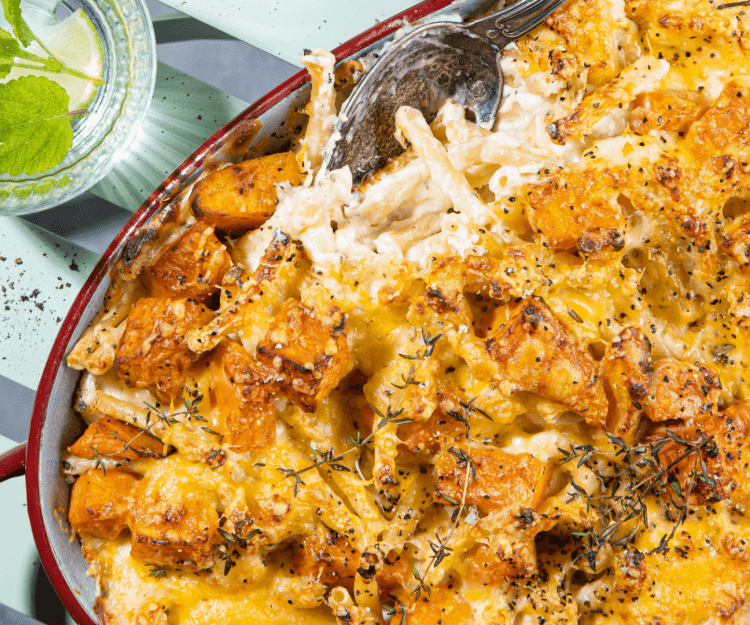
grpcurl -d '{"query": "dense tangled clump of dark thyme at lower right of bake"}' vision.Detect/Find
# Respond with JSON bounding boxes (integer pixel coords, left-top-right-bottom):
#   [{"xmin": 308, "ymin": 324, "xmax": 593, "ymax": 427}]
[{"xmin": 559, "ymin": 430, "xmax": 716, "ymax": 569}]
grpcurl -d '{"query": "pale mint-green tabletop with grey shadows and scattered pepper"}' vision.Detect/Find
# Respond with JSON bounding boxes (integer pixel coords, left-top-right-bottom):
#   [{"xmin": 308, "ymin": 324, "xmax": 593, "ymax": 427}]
[{"xmin": 0, "ymin": 0, "xmax": 416, "ymax": 625}]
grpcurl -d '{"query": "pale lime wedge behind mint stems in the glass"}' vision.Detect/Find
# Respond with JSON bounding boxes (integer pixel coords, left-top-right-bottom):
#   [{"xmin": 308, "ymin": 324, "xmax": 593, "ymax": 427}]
[{"xmin": 0, "ymin": 9, "xmax": 102, "ymax": 111}]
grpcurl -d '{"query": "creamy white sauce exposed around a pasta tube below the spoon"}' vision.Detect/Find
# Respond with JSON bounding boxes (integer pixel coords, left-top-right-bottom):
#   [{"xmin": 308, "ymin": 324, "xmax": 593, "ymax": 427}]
[{"xmin": 234, "ymin": 50, "xmax": 592, "ymax": 273}]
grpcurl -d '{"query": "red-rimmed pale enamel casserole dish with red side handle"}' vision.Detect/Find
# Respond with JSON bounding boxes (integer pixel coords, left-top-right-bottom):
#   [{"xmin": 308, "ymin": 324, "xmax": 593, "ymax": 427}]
[{"xmin": 0, "ymin": 0, "xmax": 494, "ymax": 625}]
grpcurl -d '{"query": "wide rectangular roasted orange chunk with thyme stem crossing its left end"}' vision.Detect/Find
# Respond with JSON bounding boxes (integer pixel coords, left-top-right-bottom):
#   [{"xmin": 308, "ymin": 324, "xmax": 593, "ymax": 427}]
[{"xmin": 434, "ymin": 444, "xmax": 552, "ymax": 511}]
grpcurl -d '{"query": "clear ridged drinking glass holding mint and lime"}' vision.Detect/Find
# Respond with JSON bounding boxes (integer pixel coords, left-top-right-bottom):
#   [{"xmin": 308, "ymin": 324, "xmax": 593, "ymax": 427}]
[{"xmin": 0, "ymin": 0, "xmax": 156, "ymax": 215}]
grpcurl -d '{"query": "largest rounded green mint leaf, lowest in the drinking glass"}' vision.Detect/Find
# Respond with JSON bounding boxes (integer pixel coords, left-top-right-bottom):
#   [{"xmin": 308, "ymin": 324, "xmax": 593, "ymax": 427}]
[{"xmin": 0, "ymin": 75, "xmax": 73, "ymax": 176}]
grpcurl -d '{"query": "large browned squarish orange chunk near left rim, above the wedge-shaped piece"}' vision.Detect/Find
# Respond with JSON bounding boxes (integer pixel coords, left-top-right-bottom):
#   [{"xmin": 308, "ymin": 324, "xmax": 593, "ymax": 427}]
[{"xmin": 115, "ymin": 297, "xmax": 213, "ymax": 400}]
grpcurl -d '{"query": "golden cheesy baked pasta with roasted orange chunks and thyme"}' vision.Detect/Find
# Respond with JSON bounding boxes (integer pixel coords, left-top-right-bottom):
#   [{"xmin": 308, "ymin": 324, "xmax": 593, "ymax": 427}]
[{"xmin": 62, "ymin": 0, "xmax": 750, "ymax": 625}]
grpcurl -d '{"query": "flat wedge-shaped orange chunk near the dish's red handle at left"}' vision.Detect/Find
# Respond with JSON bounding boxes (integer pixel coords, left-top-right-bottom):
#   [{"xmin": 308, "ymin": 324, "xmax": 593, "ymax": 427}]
[{"xmin": 68, "ymin": 417, "xmax": 167, "ymax": 460}]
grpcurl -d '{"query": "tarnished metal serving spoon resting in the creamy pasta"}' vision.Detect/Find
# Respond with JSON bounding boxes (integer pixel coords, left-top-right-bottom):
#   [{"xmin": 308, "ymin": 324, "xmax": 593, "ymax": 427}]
[{"xmin": 323, "ymin": 0, "xmax": 563, "ymax": 183}]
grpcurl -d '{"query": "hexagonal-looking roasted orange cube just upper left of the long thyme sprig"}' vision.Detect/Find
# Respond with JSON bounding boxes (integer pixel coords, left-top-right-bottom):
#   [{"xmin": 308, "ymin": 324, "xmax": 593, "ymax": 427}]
[{"xmin": 258, "ymin": 299, "xmax": 349, "ymax": 412}]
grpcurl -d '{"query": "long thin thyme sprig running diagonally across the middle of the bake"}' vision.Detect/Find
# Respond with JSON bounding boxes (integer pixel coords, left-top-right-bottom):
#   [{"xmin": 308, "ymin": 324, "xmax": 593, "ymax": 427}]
[{"xmin": 276, "ymin": 330, "xmax": 443, "ymax": 497}]
